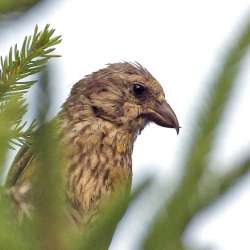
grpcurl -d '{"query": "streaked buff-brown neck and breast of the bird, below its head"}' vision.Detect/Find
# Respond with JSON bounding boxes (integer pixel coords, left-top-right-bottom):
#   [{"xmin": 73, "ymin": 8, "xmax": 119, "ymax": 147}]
[{"xmin": 61, "ymin": 114, "xmax": 136, "ymax": 222}]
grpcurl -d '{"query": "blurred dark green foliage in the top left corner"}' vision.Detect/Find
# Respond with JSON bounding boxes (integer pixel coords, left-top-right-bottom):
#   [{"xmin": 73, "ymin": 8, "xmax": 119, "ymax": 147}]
[{"xmin": 0, "ymin": 0, "xmax": 42, "ymax": 16}]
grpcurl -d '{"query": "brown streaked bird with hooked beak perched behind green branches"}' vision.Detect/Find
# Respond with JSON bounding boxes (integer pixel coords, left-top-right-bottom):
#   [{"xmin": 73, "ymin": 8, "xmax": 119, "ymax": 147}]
[{"xmin": 7, "ymin": 62, "xmax": 180, "ymax": 224}]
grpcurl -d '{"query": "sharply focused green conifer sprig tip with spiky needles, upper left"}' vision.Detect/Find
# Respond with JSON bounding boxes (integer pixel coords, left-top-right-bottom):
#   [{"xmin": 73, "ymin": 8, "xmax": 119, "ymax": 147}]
[{"xmin": 0, "ymin": 25, "xmax": 61, "ymax": 98}]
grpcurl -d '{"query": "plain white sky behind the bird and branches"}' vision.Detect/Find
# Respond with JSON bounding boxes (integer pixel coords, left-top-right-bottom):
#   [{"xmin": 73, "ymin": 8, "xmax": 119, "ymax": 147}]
[{"xmin": 0, "ymin": 0, "xmax": 250, "ymax": 250}]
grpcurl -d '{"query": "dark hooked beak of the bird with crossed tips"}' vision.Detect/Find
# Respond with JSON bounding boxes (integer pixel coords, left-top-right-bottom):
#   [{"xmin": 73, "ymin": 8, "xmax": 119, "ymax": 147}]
[{"xmin": 144, "ymin": 101, "xmax": 180, "ymax": 134}]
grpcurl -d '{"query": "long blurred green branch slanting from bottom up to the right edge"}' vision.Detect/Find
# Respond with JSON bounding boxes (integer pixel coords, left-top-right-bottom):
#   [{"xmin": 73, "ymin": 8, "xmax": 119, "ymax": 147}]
[{"xmin": 143, "ymin": 16, "xmax": 250, "ymax": 250}]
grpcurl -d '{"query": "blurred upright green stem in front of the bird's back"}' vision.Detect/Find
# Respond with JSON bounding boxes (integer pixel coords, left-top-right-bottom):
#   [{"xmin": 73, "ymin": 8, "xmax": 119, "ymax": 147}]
[{"xmin": 31, "ymin": 67, "xmax": 69, "ymax": 250}]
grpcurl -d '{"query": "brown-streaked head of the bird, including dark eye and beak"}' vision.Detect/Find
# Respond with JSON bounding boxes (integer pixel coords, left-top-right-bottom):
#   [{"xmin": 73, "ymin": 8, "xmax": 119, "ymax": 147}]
[{"xmin": 67, "ymin": 62, "xmax": 180, "ymax": 134}]
